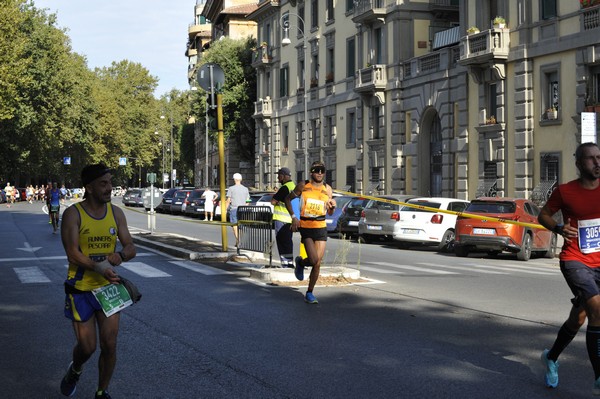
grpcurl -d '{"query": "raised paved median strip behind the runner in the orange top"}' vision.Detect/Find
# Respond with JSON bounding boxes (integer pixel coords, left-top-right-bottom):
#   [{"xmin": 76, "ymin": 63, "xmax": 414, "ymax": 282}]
[{"xmin": 132, "ymin": 233, "xmax": 360, "ymax": 285}]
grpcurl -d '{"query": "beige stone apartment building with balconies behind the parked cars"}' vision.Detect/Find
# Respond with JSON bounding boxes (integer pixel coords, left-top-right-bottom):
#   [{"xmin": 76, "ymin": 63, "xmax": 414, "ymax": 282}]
[{"xmin": 248, "ymin": 0, "xmax": 600, "ymax": 202}]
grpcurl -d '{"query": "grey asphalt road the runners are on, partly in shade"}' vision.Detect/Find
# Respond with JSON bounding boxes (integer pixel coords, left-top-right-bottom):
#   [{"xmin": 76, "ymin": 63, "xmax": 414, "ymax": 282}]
[{"xmin": 0, "ymin": 200, "xmax": 593, "ymax": 398}]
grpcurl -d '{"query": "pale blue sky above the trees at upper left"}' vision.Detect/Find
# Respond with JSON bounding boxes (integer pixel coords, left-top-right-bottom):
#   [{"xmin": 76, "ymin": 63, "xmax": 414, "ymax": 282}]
[{"xmin": 34, "ymin": 0, "xmax": 196, "ymax": 97}]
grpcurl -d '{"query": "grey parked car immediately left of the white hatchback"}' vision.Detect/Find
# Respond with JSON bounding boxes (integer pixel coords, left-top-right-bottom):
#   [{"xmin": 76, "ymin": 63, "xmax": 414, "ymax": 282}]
[{"xmin": 358, "ymin": 195, "xmax": 415, "ymax": 243}]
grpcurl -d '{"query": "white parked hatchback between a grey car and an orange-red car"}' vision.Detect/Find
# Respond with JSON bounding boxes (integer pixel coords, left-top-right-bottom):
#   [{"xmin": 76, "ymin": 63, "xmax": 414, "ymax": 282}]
[{"xmin": 394, "ymin": 197, "xmax": 469, "ymax": 252}]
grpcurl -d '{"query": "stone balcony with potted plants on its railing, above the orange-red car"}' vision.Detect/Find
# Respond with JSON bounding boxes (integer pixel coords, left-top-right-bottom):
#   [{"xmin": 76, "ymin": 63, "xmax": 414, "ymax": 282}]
[{"xmin": 458, "ymin": 28, "xmax": 510, "ymax": 81}]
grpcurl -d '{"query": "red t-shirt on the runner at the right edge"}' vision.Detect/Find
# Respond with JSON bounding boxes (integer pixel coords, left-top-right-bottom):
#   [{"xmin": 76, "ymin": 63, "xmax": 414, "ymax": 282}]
[{"xmin": 546, "ymin": 180, "xmax": 600, "ymax": 267}]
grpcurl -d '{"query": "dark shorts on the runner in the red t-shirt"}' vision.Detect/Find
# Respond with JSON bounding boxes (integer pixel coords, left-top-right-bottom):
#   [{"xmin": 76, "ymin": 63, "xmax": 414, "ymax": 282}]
[{"xmin": 560, "ymin": 260, "xmax": 600, "ymax": 306}]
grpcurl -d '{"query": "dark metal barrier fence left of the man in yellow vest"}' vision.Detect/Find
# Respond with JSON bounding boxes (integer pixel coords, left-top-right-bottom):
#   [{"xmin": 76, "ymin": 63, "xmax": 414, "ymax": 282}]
[{"xmin": 237, "ymin": 206, "xmax": 273, "ymax": 267}]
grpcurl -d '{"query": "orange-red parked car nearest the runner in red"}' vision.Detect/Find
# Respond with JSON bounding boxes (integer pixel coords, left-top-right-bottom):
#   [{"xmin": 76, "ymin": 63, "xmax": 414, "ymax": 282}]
[{"xmin": 454, "ymin": 197, "xmax": 557, "ymax": 261}]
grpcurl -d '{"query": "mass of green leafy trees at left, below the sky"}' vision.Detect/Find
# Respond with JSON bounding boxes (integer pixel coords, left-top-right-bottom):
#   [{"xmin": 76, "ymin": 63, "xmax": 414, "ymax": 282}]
[{"xmin": 0, "ymin": 0, "xmax": 189, "ymax": 186}]
